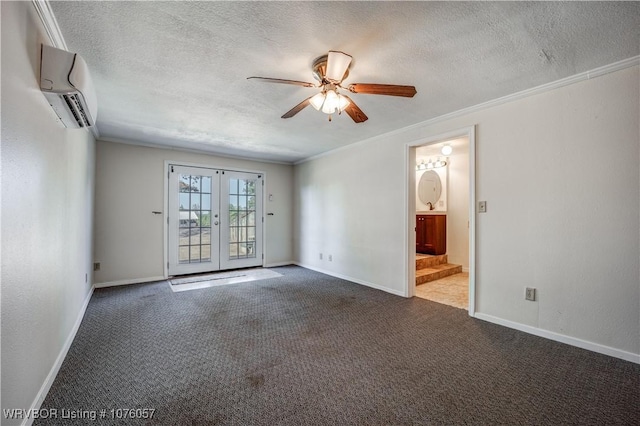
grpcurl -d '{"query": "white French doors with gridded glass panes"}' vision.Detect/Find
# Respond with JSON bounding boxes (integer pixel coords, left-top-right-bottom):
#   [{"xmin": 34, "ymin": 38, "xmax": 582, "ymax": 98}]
[{"xmin": 167, "ymin": 164, "xmax": 264, "ymax": 275}]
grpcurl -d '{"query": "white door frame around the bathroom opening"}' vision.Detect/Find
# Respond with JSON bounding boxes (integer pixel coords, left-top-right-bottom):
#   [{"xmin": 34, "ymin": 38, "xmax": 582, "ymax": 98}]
[{"xmin": 404, "ymin": 125, "xmax": 476, "ymax": 317}]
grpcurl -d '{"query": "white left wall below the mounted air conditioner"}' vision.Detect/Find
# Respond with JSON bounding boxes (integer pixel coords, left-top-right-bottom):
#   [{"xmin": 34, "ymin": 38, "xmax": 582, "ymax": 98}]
[{"xmin": 1, "ymin": 2, "xmax": 95, "ymax": 424}]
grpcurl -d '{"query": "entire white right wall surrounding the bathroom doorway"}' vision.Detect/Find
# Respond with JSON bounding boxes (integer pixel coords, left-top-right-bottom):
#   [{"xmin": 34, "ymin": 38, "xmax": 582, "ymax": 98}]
[{"xmin": 294, "ymin": 65, "xmax": 640, "ymax": 360}]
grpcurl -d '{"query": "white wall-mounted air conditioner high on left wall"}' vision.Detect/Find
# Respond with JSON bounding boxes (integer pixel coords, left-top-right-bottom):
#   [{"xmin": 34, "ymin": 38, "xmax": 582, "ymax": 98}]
[{"xmin": 40, "ymin": 45, "xmax": 98, "ymax": 129}]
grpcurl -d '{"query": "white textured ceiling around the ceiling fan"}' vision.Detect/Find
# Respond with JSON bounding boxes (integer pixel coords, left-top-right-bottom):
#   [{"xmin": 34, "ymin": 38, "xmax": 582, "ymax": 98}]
[{"xmin": 51, "ymin": 1, "xmax": 640, "ymax": 162}]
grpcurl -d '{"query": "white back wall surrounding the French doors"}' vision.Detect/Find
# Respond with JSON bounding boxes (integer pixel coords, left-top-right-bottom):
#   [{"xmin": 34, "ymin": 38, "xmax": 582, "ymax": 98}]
[{"xmin": 94, "ymin": 141, "xmax": 293, "ymax": 285}]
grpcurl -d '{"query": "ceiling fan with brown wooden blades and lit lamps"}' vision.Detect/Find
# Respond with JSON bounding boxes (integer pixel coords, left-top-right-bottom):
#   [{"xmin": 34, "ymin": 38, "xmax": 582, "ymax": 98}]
[{"xmin": 247, "ymin": 50, "xmax": 417, "ymax": 123}]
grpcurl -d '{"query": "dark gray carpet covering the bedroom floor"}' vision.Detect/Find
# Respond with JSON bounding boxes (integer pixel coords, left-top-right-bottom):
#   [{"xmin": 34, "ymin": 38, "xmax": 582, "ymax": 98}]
[{"xmin": 36, "ymin": 266, "xmax": 640, "ymax": 425}]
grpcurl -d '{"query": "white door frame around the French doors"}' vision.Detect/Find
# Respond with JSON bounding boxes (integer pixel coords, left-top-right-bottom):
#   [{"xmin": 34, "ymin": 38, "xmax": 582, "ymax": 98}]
[{"xmin": 162, "ymin": 160, "xmax": 267, "ymax": 280}]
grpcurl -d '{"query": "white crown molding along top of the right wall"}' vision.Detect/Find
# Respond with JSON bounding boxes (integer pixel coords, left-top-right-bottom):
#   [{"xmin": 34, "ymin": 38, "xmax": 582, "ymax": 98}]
[{"xmin": 294, "ymin": 56, "xmax": 640, "ymax": 165}]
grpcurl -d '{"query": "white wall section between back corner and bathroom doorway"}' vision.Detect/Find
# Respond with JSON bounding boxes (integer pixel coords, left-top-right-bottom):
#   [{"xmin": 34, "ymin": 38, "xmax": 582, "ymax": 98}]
[{"xmin": 294, "ymin": 138, "xmax": 408, "ymax": 294}]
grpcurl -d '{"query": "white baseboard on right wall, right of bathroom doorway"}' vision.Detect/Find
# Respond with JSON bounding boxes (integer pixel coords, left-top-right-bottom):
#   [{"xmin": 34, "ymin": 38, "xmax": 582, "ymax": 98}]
[{"xmin": 474, "ymin": 312, "xmax": 640, "ymax": 364}]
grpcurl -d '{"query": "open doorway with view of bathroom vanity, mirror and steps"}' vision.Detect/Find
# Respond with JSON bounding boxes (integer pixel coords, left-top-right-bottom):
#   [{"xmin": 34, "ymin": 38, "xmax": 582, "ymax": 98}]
[{"xmin": 407, "ymin": 127, "xmax": 475, "ymax": 316}]
